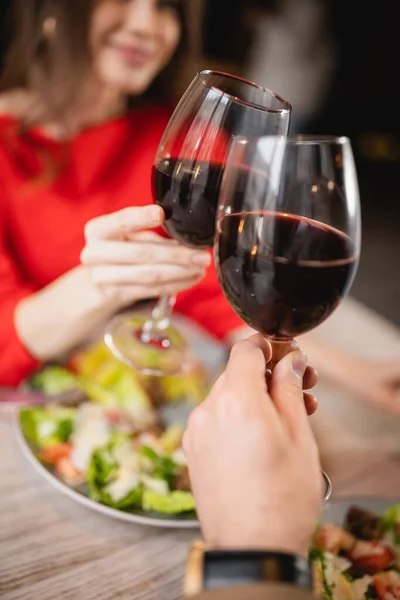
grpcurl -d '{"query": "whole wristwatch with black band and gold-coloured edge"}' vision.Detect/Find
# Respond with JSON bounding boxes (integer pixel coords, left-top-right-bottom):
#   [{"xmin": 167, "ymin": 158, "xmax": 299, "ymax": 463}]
[{"xmin": 184, "ymin": 542, "xmax": 313, "ymax": 598}]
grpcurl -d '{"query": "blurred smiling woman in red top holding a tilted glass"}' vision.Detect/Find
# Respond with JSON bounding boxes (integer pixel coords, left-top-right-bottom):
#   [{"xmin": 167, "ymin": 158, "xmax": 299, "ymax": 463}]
[{"xmin": 0, "ymin": 0, "xmax": 247, "ymax": 385}]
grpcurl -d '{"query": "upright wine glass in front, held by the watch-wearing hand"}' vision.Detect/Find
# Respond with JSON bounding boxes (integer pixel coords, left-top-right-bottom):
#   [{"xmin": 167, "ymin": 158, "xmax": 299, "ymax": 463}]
[{"xmin": 215, "ymin": 136, "xmax": 361, "ymax": 370}]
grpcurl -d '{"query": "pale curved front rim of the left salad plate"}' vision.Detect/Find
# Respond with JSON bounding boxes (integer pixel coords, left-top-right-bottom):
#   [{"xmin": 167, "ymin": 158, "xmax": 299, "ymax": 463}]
[{"xmin": 13, "ymin": 407, "xmax": 200, "ymax": 529}]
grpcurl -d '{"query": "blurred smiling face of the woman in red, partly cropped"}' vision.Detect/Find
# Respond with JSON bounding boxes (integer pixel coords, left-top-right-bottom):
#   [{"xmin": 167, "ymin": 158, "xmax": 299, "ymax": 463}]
[{"xmin": 90, "ymin": 0, "xmax": 181, "ymax": 96}]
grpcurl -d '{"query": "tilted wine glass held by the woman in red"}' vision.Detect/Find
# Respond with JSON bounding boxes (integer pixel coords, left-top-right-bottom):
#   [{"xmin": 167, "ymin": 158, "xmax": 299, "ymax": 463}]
[{"xmin": 105, "ymin": 71, "xmax": 291, "ymax": 375}]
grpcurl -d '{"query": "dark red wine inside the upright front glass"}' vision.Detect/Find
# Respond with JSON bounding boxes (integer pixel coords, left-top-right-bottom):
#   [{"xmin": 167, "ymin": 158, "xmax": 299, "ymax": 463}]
[{"xmin": 218, "ymin": 211, "xmax": 357, "ymax": 340}]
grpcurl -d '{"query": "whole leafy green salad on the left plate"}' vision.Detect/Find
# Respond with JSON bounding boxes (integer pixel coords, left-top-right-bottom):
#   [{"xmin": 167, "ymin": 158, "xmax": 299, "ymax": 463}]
[{"xmin": 20, "ymin": 343, "xmax": 208, "ymax": 516}]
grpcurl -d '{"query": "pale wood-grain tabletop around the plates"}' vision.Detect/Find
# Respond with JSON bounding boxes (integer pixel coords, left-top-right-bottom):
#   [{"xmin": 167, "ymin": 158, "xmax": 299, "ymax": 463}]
[{"xmin": 0, "ymin": 300, "xmax": 400, "ymax": 600}]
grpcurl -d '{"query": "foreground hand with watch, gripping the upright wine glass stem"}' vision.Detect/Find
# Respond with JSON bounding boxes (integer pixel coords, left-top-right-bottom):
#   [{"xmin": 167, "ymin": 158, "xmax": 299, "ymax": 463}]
[{"xmin": 183, "ymin": 335, "xmax": 322, "ymax": 553}]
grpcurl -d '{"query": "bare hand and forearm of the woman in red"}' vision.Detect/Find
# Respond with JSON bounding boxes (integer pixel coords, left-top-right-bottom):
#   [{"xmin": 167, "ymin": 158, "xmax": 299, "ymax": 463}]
[{"xmin": 15, "ymin": 206, "xmax": 211, "ymax": 361}]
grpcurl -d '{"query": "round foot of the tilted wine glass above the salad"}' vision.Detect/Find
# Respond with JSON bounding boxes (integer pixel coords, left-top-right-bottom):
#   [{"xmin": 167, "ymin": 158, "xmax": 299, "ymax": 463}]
[{"xmin": 104, "ymin": 312, "xmax": 191, "ymax": 377}]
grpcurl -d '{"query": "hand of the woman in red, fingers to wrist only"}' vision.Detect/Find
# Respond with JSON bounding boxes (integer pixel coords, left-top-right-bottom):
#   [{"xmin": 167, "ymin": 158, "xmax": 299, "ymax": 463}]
[{"xmin": 81, "ymin": 205, "xmax": 211, "ymax": 308}]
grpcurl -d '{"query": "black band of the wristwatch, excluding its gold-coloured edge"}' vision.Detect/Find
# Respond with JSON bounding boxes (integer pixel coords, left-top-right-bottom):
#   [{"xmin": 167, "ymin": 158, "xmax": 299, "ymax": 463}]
[{"xmin": 203, "ymin": 550, "xmax": 313, "ymax": 590}]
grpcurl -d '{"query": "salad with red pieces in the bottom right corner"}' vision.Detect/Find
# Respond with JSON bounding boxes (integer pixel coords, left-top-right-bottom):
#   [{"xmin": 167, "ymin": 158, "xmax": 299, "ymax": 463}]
[{"xmin": 310, "ymin": 505, "xmax": 400, "ymax": 600}]
